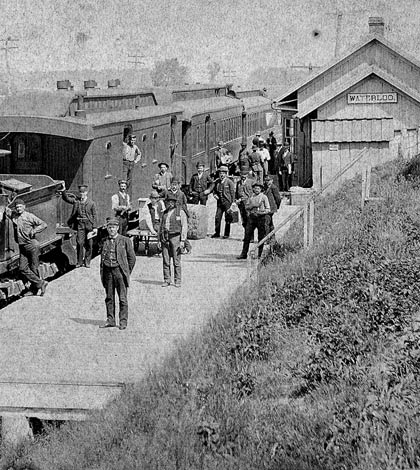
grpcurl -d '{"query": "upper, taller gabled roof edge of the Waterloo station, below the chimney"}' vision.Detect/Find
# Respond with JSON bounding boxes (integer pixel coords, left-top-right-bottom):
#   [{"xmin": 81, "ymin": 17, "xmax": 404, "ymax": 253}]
[{"xmin": 273, "ymin": 34, "xmax": 420, "ymax": 102}]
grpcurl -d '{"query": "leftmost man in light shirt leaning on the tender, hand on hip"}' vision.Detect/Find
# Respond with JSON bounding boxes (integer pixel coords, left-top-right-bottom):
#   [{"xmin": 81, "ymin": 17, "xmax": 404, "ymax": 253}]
[{"xmin": 6, "ymin": 198, "xmax": 48, "ymax": 296}]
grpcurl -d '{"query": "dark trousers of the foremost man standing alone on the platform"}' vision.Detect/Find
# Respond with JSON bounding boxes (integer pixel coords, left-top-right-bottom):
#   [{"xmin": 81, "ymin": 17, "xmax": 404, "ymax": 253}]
[{"xmin": 103, "ymin": 266, "xmax": 128, "ymax": 326}]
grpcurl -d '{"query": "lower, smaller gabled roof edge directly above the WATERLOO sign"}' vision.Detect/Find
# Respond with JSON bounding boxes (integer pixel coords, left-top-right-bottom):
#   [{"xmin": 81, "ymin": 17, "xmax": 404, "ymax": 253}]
[{"xmin": 296, "ymin": 64, "xmax": 420, "ymax": 119}]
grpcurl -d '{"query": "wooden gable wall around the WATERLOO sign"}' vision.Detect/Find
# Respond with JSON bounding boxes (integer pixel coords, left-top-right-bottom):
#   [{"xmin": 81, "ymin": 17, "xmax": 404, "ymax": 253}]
[{"xmin": 318, "ymin": 76, "xmax": 420, "ymax": 131}]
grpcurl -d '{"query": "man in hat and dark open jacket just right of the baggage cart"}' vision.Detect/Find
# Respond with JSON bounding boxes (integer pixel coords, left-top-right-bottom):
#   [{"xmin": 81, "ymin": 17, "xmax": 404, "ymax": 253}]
[{"xmin": 211, "ymin": 165, "xmax": 235, "ymax": 238}]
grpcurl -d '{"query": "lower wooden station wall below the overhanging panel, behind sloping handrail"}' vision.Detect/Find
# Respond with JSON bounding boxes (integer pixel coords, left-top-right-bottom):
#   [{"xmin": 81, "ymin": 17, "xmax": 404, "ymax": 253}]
[{"xmin": 312, "ymin": 142, "xmax": 392, "ymax": 192}]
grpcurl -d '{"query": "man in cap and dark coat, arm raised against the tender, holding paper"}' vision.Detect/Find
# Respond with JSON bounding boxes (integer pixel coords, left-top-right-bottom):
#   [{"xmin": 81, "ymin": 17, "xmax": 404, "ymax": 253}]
[{"xmin": 62, "ymin": 184, "xmax": 97, "ymax": 268}]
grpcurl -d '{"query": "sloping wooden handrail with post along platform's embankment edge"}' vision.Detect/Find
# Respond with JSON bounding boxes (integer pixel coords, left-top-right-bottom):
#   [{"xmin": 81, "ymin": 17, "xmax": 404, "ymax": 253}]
[{"xmin": 252, "ymin": 147, "xmax": 368, "ymax": 259}]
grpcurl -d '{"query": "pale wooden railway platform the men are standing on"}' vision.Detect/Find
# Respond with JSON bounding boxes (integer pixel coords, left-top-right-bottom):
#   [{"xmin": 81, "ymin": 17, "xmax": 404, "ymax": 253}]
[{"xmin": 0, "ymin": 196, "xmax": 296, "ymax": 441}]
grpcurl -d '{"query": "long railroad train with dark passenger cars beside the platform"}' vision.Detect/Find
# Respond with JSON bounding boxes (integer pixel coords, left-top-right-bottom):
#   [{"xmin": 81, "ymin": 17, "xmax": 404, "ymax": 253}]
[{"xmin": 0, "ymin": 80, "xmax": 278, "ymax": 298}]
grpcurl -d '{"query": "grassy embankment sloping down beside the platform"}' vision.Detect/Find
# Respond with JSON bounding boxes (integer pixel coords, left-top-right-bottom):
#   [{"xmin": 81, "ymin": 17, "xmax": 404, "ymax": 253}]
[{"xmin": 0, "ymin": 159, "xmax": 420, "ymax": 470}]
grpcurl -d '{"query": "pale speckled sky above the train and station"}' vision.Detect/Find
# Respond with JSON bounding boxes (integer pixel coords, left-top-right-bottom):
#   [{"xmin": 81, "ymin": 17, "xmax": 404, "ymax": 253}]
[{"xmin": 0, "ymin": 0, "xmax": 420, "ymax": 80}]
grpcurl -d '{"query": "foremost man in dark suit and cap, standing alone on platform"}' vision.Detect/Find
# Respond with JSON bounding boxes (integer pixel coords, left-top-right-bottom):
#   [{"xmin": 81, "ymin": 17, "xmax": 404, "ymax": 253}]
[{"xmin": 99, "ymin": 217, "xmax": 136, "ymax": 330}]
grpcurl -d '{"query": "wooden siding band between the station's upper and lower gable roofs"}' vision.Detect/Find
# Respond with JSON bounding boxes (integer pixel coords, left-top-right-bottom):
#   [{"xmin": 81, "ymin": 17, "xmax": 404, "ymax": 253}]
[{"xmin": 298, "ymin": 41, "xmax": 420, "ymax": 108}]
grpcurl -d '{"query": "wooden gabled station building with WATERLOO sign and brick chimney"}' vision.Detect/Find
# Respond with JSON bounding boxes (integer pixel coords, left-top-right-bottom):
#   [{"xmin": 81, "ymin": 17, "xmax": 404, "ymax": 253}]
[{"xmin": 274, "ymin": 17, "xmax": 420, "ymax": 189}]
